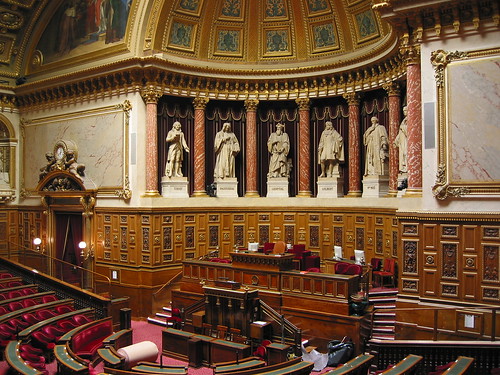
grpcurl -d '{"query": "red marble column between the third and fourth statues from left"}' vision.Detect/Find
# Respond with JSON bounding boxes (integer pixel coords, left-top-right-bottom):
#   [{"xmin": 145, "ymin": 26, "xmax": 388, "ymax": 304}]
[{"xmin": 296, "ymin": 98, "xmax": 311, "ymax": 197}]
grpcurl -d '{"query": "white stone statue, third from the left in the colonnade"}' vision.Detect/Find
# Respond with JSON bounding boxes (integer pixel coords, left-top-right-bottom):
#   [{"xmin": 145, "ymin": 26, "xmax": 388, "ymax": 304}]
[{"xmin": 267, "ymin": 123, "xmax": 291, "ymax": 178}]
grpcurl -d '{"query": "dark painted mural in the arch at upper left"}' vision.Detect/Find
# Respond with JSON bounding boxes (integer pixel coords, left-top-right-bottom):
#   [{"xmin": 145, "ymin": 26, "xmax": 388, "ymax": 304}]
[{"xmin": 37, "ymin": 0, "xmax": 132, "ymax": 64}]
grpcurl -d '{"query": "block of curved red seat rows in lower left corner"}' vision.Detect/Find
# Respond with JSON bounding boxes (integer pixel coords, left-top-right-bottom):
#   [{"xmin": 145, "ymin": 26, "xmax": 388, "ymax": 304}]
[{"xmin": 0, "ymin": 271, "xmax": 94, "ymax": 374}]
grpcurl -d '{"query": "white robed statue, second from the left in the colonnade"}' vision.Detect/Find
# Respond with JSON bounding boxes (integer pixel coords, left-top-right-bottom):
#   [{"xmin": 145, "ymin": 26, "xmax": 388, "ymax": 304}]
[{"xmin": 214, "ymin": 122, "xmax": 240, "ymax": 179}]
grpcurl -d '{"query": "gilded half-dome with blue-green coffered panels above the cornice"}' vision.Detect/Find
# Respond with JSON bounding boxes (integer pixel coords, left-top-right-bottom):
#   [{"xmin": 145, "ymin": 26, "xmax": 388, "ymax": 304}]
[{"xmin": 150, "ymin": 0, "xmax": 395, "ymax": 73}]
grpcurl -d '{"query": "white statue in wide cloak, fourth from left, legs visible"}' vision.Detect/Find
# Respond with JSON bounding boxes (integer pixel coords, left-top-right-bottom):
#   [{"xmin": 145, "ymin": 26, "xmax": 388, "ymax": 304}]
[{"xmin": 318, "ymin": 121, "xmax": 344, "ymax": 177}]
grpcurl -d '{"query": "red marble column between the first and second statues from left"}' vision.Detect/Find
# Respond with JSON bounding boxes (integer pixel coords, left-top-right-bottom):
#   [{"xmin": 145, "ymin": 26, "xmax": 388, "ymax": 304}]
[{"xmin": 193, "ymin": 97, "xmax": 209, "ymax": 197}]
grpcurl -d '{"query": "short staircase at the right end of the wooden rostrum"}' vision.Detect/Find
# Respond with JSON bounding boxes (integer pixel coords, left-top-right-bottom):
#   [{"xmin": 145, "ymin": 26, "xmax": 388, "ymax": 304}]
[{"xmin": 368, "ymin": 288, "xmax": 398, "ymax": 340}]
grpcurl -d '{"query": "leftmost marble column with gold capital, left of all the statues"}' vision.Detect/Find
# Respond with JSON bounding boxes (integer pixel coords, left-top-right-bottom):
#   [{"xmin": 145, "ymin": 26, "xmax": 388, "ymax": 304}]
[{"xmin": 141, "ymin": 87, "xmax": 162, "ymax": 197}]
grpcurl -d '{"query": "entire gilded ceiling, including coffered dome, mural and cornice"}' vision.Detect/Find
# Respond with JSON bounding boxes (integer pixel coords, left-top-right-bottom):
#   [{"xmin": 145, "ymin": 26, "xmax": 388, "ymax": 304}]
[{"xmin": 0, "ymin": 0, "xmax": 499, "ymax": 106}]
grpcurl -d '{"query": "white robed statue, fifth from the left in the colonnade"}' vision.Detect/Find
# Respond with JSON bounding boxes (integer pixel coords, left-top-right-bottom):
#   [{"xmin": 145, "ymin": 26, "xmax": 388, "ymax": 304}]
[{"xmin": 363, "ymin": 116, "xmax": 389, "ymax": 176}]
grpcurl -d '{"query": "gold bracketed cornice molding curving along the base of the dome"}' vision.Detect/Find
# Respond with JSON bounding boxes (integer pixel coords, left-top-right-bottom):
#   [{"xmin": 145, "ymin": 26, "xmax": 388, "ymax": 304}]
[{"xmin": 15, "ymin": 55, "xmax": 406, "ymax": 109}]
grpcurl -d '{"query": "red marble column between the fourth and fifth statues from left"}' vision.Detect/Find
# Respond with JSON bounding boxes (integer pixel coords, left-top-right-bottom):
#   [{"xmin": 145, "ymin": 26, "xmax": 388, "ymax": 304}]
[{"xmin": 344, "ymin": 92, "xmax": 362, "ymax": 197}]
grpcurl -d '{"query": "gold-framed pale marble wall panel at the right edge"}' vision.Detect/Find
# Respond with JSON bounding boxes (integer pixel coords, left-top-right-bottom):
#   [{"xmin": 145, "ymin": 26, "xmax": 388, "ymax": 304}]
[{"xmin": 431, "ymin": 48, "xmax": 500, "ymax": 200}]
